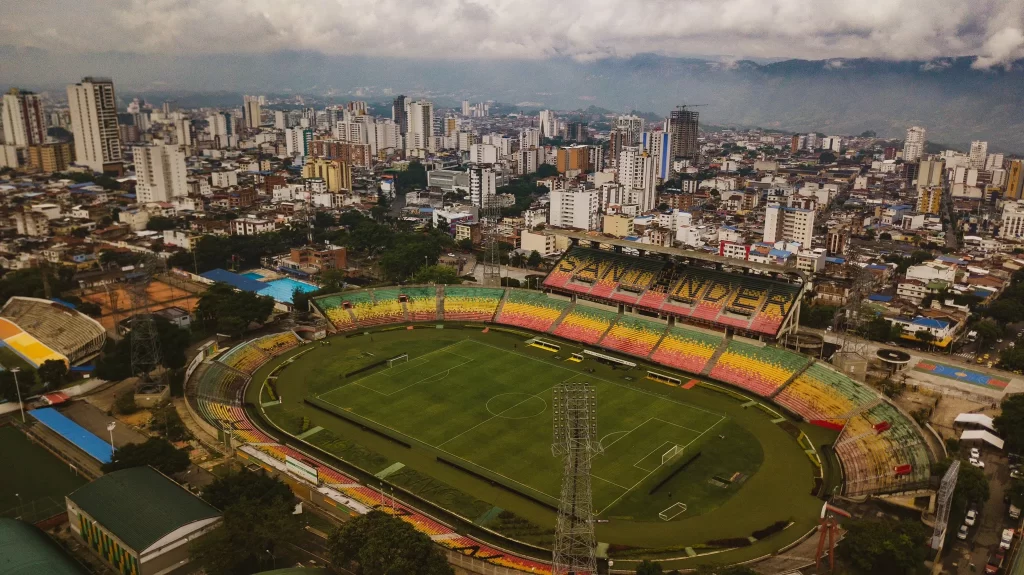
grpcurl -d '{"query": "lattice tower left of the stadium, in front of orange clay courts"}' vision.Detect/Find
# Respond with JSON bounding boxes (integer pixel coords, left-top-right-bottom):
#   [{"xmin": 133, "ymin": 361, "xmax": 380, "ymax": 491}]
[{"xmin": 126, "ymin": 255, "xmax": 163, "ymax": 384}]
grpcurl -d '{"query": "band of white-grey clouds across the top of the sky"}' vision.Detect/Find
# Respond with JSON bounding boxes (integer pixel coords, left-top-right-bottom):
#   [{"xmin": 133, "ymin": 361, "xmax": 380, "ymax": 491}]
[{"xmin": 0, "ymin": 0, "xmax": 1024, "ymax": 68}]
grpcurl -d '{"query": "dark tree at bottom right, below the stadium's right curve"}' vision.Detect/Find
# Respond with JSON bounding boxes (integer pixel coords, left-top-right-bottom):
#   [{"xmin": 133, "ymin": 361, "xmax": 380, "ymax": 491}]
[{"xmin": 838, "ymin": 520, "xmax": 928, "ymax": 575}]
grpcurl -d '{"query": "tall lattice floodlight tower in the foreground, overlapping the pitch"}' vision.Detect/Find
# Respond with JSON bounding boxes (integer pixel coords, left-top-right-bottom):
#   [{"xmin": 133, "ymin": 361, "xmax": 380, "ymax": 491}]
[{"xmin": 551, "ymin": 384, "xmax": 601, "ymax": 575}]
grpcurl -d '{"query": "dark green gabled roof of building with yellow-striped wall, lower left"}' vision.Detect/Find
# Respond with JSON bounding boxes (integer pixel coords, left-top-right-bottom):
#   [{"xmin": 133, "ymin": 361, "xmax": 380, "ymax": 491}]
[{"xmin": 68, "ymin": 467, "xmax": 220, "ymax": 552}]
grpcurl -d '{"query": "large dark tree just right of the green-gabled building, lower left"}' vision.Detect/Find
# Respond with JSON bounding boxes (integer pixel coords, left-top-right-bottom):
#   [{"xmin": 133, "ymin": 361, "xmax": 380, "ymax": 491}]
[{"xmin": 191, "ymin": 470, "xmax": 301, "ymax": 575}]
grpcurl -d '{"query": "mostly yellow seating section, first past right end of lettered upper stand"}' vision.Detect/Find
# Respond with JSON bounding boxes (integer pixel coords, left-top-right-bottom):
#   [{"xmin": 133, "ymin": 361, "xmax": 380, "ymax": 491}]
[{"xmin": 774, "ymin": 363, "xmax": 878, "ymax": 422}]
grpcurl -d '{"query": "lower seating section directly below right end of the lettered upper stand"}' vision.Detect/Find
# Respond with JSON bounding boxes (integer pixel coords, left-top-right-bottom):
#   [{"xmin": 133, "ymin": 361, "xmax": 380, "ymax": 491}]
[{"xmin": 711, "ymin": 341, "xmax": 808, "ymax": 397}]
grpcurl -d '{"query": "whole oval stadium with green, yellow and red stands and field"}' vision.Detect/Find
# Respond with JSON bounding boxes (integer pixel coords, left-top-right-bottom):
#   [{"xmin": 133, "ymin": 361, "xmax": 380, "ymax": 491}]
[{"xmin": 186, "ymin": 247, "xmax": 936, "ymax": 573}]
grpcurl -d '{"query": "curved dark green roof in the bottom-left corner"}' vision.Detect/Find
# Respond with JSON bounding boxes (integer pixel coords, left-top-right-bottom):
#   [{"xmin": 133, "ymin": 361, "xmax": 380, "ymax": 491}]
[{"xmin": 0, "ymin": 518, "xmax": 88, "ymax": 575}]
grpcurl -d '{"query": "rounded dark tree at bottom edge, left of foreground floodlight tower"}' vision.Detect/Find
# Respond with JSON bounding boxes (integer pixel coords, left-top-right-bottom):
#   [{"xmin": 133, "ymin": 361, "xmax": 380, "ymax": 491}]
[{"xmin": 327, "ymin": 511, "xmax": 455, "ymax": 575}]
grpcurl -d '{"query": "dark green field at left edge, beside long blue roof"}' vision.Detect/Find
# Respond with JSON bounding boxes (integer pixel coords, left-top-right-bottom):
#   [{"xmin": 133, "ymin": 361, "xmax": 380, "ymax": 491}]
[{"xmin": 0, "ymin": 426, "xmax": 86, "ymax": 521}]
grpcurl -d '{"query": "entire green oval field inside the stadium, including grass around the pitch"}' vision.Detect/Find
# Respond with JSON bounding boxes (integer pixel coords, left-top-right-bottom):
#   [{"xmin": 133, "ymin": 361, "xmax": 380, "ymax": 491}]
[{"xmin": 256, "ymin": 325, "xmax": 835, "ymax": 557}]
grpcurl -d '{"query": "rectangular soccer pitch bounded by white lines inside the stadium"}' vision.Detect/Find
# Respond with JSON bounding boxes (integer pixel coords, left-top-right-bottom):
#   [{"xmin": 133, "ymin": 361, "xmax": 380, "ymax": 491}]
[{"xmin": 318, "ymin": 339, "xmax": 727, "ymax": 514}]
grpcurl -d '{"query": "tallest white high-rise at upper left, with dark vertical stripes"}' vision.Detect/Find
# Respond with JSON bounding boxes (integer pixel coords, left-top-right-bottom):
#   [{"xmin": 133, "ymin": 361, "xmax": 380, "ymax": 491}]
[{"xmin": 68, "ymin": 77, "xmax": 124, "ymax": 174}]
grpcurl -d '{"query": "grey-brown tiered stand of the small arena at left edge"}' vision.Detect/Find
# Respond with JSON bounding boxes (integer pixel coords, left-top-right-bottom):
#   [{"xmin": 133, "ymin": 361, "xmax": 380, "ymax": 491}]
[{"xmin": 0, "ymin": 297, "xmax": 106, "ymax": 363}]
